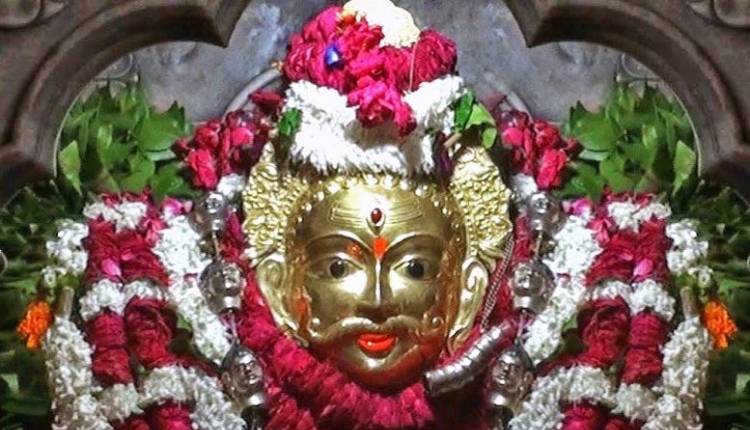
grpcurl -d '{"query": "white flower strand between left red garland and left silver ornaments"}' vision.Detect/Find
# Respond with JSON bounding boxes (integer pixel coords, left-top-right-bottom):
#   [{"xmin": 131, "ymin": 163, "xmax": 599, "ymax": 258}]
[{"xmin": 153, "ymin": 215, "xmax": 231, "ymax": 363}]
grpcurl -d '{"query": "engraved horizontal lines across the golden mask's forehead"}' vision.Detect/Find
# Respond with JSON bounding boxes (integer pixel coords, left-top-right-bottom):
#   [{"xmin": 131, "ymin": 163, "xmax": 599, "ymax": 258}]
[{"xmin": 328, "ymin": 196, "xmax": 422, "ymax": 227}]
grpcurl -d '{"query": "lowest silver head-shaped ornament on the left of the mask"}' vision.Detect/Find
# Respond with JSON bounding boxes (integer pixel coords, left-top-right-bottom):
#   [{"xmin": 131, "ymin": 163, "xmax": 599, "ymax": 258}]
[{"xmin": 221, "ymin": 343, "xmax": 266, "ymax": 430}]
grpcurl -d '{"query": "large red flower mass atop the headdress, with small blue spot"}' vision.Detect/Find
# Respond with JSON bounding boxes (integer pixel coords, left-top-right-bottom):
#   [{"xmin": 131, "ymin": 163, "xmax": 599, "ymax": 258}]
[{"xmin": 284, "ymin": 6, "xmax": 458, "ymax": 135}]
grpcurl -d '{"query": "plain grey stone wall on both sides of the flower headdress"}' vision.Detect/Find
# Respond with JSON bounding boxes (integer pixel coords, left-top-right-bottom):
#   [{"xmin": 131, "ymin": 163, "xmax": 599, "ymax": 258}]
[{"xmin": 110, "ymin": 0, "xmax": 620, "ymax": 120}]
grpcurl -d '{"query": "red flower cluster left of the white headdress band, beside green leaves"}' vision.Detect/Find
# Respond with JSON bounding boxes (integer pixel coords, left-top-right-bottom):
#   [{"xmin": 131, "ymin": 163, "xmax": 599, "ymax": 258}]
[{"xmin": 173, "ymin": 91, "xmax": 282, "ymax": 190}]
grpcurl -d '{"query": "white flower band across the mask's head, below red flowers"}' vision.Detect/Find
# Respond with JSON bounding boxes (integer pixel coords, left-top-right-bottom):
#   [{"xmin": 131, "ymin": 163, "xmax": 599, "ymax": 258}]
[{"xmin": 285, "ymin": 76, "xmax": 465, "ymax": 176}]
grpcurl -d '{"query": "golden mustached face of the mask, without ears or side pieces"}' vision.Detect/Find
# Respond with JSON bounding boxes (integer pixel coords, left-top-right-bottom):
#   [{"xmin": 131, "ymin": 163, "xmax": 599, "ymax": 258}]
[{"xmin": 288, "ymin": 184, "xmax": 464, "ymax": 386}]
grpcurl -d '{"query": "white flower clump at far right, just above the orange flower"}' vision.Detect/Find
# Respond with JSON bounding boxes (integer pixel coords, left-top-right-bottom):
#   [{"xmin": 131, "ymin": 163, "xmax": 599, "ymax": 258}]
[{"xmin": 667, "ymin": 220, "xmax": 713, "ymax": 285}]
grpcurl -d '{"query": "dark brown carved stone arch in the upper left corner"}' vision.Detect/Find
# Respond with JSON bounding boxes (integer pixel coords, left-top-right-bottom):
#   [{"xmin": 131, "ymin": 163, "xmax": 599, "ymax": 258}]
[{"xmin": 0, "ymin": 0, "xmax": 249, "ymax": 204}]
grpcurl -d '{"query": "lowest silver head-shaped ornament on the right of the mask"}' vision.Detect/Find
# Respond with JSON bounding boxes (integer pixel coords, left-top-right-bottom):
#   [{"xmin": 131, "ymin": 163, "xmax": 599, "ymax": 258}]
[{"xmin": 487, "ymin": 345, "xmax": 534, "ymax": 420}]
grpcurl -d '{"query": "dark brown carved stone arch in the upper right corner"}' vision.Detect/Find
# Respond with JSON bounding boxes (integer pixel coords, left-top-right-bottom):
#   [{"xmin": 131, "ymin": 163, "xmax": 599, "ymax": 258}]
[{"xmin": 506, "ymin": 0, "xmax": 750, "ymax": 199}]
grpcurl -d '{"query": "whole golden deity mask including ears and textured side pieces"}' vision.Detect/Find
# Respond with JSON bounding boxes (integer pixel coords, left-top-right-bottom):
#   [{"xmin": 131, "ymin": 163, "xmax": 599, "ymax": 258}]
[{"xmin": 244, "ymin": 145, "xmax": 510, "ymax": 389}]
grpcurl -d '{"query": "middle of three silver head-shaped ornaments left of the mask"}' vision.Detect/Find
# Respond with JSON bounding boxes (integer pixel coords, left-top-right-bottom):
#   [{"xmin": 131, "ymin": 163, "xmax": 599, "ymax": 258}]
[{"xmin": 200, "ymin": 259, "xmax": 245, "ymax": 314}]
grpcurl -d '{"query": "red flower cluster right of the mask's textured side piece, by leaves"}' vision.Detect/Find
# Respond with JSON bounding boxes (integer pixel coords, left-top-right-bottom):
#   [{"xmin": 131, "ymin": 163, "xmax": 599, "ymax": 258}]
[{"xmin": 497, "ymin": 111, "xmax": 579, "ymax": 190}]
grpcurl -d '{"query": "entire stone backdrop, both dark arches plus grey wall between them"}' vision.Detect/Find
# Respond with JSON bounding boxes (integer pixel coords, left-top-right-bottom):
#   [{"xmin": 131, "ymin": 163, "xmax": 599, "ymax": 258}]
[{"xmin": 0, "ymin": 0, "xmax": 750, "ymax": 204}]
